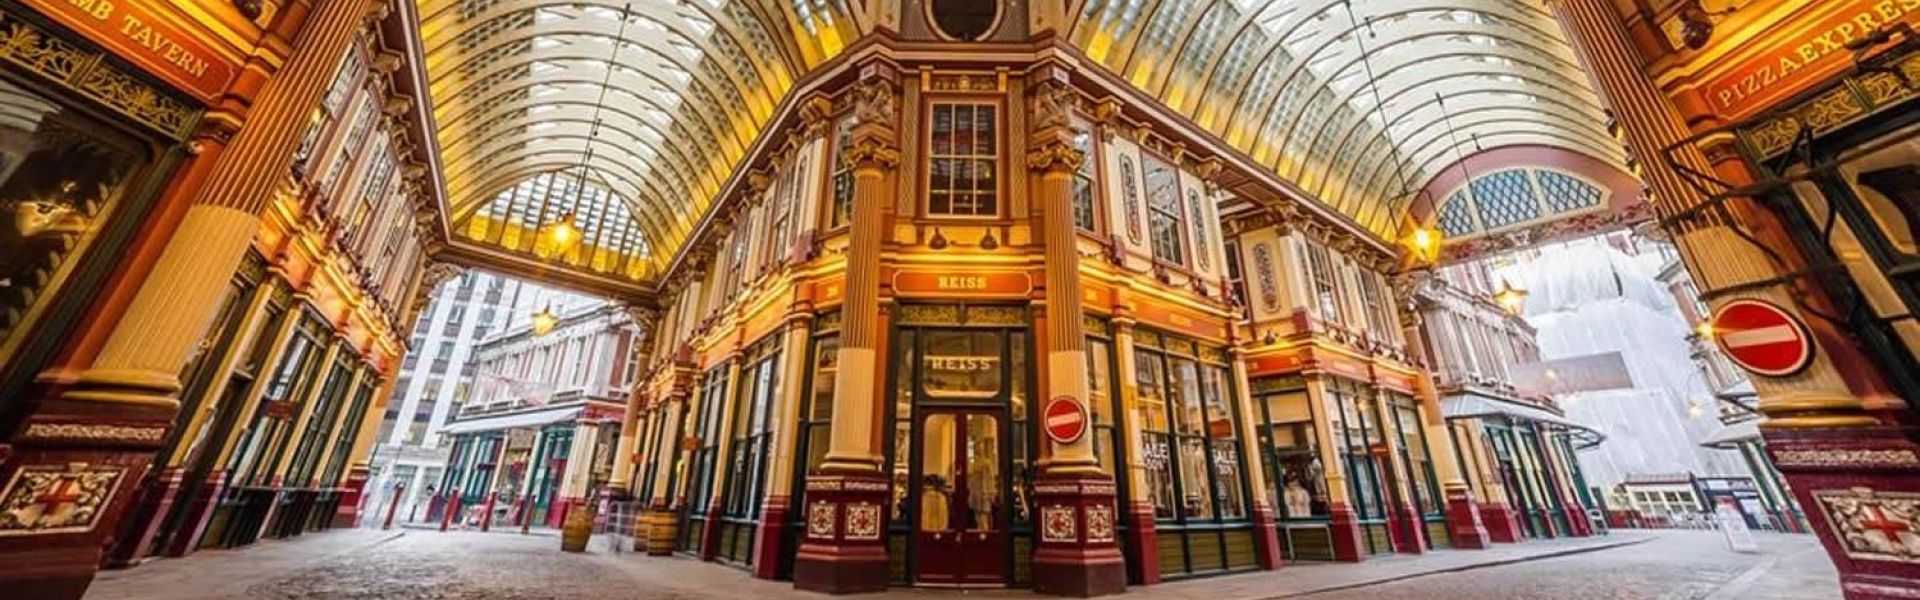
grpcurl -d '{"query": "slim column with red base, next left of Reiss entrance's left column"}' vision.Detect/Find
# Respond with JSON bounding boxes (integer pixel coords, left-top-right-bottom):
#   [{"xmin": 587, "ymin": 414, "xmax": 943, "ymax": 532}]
[{"xmin": 753, "ymin": 301, "xmax": 814, "ymax": 579}]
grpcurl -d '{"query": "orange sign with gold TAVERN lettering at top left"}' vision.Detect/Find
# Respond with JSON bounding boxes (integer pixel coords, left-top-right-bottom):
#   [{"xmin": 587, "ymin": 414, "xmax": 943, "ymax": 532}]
[{"xmin": 23, "ymin": 0, "xmax": 236, "ymax": 100}]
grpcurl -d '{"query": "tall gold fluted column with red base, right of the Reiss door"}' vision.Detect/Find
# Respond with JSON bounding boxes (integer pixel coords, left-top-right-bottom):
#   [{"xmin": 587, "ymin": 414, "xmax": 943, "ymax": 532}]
[{"xmin": 1027, "ymin": 65, "xmax": 1127, "ymax": 598}]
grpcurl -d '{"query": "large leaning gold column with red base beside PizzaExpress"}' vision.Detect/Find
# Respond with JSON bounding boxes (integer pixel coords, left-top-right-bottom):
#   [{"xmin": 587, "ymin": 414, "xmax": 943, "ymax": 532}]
[{"xmin": 1548, "ymin": 0, "xmax": 1920, "ymax": 598}]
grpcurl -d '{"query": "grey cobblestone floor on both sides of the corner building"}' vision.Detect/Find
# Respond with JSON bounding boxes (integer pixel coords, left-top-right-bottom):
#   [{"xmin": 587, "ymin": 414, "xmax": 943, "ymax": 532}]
[{"xmin": 86, "ymin": 531, "xmax": 1839, "ymax": 600}]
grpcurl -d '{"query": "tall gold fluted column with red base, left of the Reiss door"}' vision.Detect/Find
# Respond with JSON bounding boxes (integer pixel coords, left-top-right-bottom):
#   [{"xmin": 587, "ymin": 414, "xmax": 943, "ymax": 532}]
[{"xmin": 793, "ymin": 62, "xmax": 900, "ymax": 594}]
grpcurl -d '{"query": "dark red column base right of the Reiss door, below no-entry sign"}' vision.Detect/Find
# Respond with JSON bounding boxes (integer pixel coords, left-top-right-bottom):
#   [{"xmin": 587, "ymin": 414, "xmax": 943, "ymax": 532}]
[{"xmin": 1033, "ymin": 475, "xmax": 1127, "ymax": 598}]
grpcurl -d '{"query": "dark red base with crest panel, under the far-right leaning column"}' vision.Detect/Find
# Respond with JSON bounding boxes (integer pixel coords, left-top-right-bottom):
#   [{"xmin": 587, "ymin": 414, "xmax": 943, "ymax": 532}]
[{"xmin": 1761, "ymin": 427, "xmax": 1920, "ymax": 600}]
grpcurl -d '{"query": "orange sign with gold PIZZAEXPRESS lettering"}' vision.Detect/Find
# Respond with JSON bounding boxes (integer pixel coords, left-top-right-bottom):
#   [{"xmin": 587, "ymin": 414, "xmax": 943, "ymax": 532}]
[{"xmin": 1703, "ymin": 0, "xmax": 1920, "ymax": 119}]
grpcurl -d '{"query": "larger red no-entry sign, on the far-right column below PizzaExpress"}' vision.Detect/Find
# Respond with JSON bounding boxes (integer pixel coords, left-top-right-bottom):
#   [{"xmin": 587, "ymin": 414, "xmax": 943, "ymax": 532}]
[{"xmin": 1713, "ymin": 300, "xmax": 1812, "ymax": 377}]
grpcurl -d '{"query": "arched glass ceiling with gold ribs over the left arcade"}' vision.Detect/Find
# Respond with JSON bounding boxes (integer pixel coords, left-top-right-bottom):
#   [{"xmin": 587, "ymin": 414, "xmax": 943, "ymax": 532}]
[{"xmin": 419, "ymin": 0, "xmax": 856, "ymax": 281}]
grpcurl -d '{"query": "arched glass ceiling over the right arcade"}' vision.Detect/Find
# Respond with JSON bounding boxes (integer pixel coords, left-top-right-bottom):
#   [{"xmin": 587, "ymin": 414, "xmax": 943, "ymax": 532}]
[{"xmin": 1069, "ymin": 0, "xmax": 1624, "ymax": 237}]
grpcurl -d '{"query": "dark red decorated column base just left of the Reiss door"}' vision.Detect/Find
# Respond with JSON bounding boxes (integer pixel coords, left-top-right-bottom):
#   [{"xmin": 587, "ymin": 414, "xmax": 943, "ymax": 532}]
[{"xmin": 793, "ymin": 473, "xmax": 889, "ymax": 594}]
